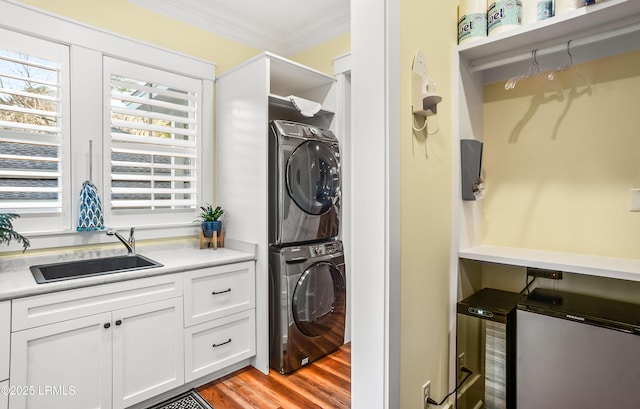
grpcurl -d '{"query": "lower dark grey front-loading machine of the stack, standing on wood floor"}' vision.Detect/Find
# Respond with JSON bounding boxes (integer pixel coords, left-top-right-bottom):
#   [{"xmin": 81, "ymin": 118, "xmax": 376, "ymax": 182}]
[{"xmin": 269, "ymin": 241, "xmax": 347, "ymax": 374}]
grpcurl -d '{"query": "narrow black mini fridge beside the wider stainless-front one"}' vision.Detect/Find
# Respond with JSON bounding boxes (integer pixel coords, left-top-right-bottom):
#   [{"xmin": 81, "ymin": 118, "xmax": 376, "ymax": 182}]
[{"xmin": 456, "ymin": 288, "xmax": 525, "ymax": 409}]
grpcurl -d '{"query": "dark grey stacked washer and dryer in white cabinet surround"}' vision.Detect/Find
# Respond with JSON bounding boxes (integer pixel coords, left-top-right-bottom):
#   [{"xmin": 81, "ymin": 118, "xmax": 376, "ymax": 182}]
[{"xmin": 269, "ymin": 120, "xmax": 347, "ymax": 373}]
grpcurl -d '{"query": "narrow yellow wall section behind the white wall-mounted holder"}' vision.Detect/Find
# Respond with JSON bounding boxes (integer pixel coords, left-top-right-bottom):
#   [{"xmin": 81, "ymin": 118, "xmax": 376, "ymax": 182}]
[{"xmin": 398, "ymin": 0, "xmax": 457, "ymax": 409}]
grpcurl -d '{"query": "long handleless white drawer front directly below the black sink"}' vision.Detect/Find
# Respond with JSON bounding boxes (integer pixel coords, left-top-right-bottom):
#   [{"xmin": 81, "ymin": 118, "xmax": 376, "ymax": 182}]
[{"xmin": 11, "ymin": 274, "xmax": 183, "ymax": 331}]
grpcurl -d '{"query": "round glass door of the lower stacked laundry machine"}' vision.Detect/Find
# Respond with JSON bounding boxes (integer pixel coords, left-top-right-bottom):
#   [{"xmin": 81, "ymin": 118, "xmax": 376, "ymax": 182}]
[{"xmin": 292, "ymin": 262, "xmax": 346, "ymax": 337}]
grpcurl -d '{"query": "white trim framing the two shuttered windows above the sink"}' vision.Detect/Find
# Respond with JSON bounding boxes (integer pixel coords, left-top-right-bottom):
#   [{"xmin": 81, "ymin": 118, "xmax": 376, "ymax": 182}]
[{"xmin": 0, "ymin": 0, "xmax": 216, "ymax": 251}]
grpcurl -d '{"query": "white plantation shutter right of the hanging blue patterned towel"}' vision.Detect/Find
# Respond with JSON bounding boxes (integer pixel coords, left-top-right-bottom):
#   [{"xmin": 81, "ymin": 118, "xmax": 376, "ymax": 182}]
[{"xmin": 105, "ymin": 58, "xmax": 201, "ymax": 221}]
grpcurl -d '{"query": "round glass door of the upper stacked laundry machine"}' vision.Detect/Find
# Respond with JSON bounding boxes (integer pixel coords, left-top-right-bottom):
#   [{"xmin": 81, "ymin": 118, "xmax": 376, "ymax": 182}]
[{"xmin": 287, "ymin": 141, "xmax": 340, "ymax": 215}]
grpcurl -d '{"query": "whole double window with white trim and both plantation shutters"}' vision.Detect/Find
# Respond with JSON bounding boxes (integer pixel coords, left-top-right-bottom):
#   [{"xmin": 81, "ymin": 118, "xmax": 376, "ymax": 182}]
[{"xmin": 0, "ymin": 3, "xmax": 215, "ymax": 245}]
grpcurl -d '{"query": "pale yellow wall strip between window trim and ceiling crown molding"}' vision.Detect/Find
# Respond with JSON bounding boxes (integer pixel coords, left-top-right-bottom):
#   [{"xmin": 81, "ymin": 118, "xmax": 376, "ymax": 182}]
[{"xmin": 22, "ymin": 0, "xmax": 261, "ymax": 74}]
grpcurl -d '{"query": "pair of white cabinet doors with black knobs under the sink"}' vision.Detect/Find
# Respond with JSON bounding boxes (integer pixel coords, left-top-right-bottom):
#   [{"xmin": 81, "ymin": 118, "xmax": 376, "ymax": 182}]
[{"xmin": 9, "ymin": 298, "xmax": 184, "ymax": 409}]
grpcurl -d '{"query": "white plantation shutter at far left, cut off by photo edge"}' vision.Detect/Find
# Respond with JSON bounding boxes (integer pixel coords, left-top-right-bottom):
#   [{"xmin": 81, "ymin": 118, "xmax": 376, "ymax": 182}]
[{"xmin": 0, "ymin": 30, "xmax": 69, "ymax": 230}]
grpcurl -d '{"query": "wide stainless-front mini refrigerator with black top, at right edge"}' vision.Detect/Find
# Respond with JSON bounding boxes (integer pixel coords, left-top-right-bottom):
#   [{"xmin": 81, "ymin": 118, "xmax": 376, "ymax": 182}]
[{"xmin": 517, "ymin": 288, "xmax": 640, "ymax": 409}]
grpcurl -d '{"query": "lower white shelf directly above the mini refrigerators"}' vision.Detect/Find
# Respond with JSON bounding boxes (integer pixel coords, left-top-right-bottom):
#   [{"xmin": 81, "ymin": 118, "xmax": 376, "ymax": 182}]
[{"xmin": 459, "ymin": 245, "xmax": 640, "ymax": 281}]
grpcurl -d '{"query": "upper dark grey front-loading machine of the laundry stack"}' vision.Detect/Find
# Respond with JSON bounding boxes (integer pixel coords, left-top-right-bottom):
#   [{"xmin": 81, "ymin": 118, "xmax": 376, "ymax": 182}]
[{"xmin": 269, "ymin": 120, "xmax": 340, "ymax": 245}]
